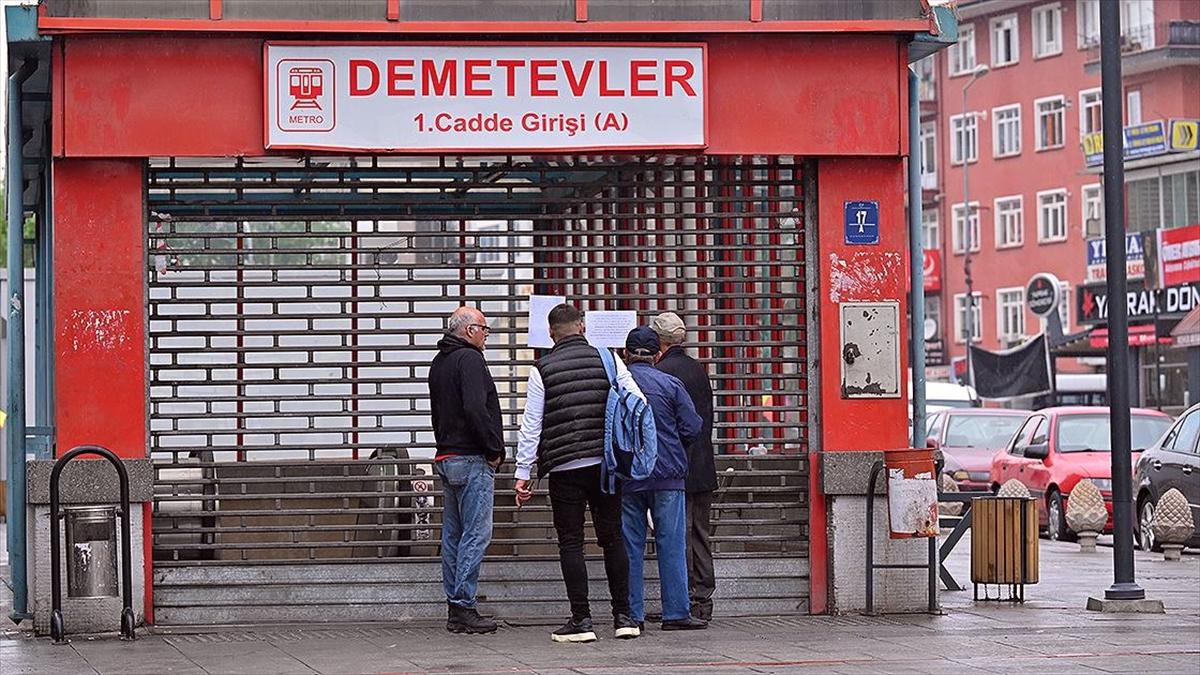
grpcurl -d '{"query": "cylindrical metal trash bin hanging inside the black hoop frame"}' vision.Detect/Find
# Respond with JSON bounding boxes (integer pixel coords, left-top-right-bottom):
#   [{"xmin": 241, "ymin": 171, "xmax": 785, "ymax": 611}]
[{"xmin": 62, "ymin": 506, "xmax": 119, "ymax": 598}]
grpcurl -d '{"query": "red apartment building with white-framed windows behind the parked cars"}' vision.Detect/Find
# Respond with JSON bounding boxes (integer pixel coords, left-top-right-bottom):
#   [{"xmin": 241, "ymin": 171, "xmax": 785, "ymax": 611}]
[{"xmin": 918, "ymin": 0, "xmax": 1200, "ymax": 407}]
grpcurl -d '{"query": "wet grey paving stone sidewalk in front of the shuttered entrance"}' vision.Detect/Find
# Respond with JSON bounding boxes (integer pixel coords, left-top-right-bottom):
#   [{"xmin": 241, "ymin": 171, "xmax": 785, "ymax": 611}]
[{"xmin": 0, "ymin": 533, "xmax": 1200, "ymax": 675}]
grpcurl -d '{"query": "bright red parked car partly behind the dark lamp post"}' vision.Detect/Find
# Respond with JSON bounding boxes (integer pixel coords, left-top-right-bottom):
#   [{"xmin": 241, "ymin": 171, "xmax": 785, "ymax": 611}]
[{"xmin": 991, "ymin": 406, "xmax": 1171, "ymax": 539}]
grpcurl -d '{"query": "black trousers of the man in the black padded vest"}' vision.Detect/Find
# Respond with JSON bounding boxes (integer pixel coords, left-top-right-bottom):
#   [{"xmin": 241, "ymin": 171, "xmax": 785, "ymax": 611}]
[{"xmin": 550, "ymin": 465, "xmax": 629, "ymax": 619}]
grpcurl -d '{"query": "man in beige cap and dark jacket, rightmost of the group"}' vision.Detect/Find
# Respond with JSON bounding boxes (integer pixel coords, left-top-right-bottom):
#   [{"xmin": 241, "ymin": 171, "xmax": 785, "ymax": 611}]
[{"xmin": 650, "ymin": 312, "xmax": 716, "ymax": 621}]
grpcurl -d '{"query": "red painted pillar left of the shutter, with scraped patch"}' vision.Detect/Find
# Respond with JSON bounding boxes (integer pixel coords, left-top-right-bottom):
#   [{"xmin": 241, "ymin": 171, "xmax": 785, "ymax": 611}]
[{"xmin": 54, "ymin": 159, "xmax": 154, "ymax": 621}]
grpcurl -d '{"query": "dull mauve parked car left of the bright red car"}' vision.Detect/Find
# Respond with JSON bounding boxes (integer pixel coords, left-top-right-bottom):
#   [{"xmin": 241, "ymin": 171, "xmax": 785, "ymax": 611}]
[{"xmin": 925, "ymin": 408, "xmax": 1033, "ymax": 492}]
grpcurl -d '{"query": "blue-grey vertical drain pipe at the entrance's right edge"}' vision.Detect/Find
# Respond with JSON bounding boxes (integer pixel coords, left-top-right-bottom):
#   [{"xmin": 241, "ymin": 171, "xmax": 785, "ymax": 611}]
[{"xmin": 908, "ymin": 68, "xmax": 925, "ymax": 448}]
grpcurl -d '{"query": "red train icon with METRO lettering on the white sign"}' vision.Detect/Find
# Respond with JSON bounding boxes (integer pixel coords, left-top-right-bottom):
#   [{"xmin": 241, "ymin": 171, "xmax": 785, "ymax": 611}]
[{"xmin": 274, "ymin": 59, "xmax": 337, "ymax": 132}]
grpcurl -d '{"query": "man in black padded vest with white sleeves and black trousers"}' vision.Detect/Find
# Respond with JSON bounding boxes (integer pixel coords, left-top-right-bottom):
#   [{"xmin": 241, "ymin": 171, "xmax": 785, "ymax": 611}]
[{"xmin": 516, "ymin": 304, "xmax": 642, "ymax": 643}]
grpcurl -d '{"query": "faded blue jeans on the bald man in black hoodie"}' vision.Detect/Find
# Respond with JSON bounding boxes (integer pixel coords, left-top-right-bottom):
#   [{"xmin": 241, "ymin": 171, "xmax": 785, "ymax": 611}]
[{"xmin": 437, "ymin": 455, "xmax": 496, "ymax": 608}]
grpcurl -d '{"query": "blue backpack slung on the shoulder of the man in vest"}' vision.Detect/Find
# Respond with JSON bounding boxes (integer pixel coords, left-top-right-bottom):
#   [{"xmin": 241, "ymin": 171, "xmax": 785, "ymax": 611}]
[{"xmin": 596, "ymin": 347, "xmax": 659, "ymax": 495}]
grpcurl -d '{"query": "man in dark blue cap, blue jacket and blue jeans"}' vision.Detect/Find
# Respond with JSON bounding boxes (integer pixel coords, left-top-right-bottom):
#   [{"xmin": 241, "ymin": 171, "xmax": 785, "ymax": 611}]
[{"xmin": 620, "ymin": 325, "xmax": 708, "ymax": 631}]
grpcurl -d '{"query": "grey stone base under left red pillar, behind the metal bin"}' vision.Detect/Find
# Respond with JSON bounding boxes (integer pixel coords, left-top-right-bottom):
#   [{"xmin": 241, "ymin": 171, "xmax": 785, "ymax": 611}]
[{"xmin": 29, "ymin": 503, "xmax": 145, "ymax": 635}]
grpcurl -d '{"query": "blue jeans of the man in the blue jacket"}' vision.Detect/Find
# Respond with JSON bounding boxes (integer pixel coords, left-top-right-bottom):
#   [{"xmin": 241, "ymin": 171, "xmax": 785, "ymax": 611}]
[{"xmin": 620, "ymin": 490, "xmax": 691, "ymax": 622}]
